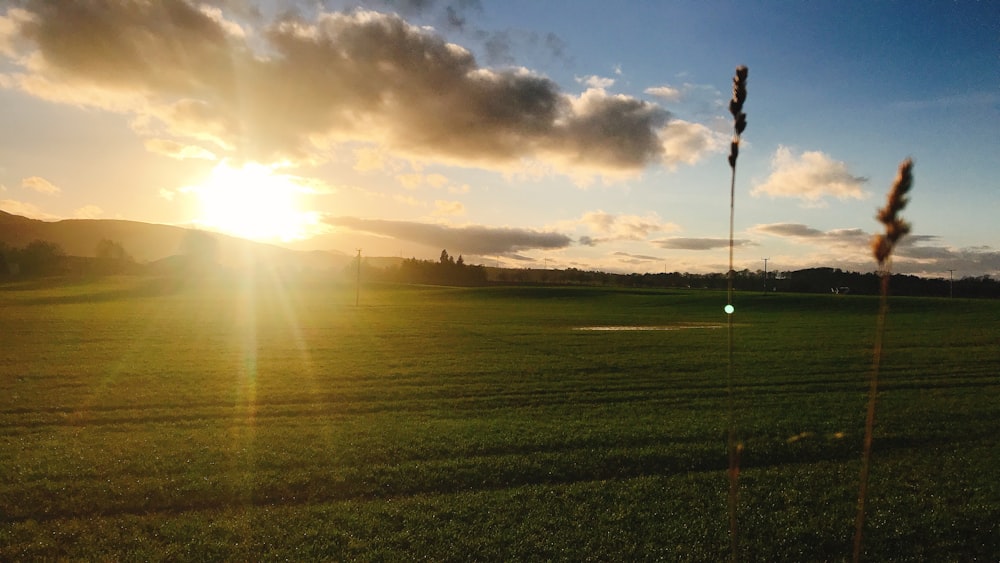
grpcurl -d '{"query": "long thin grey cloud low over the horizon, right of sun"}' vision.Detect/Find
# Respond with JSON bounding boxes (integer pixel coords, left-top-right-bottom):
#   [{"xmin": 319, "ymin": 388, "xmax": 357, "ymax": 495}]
[{"xmin": 324, "ymin": 217, "xmax": 572, "ymax": 255}]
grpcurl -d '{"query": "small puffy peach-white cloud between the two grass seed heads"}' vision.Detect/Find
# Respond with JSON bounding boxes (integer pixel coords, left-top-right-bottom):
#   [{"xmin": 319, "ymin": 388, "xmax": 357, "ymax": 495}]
[{"xmin": 750, "ymin": 146, "xmax": 869, "ymax": 204}]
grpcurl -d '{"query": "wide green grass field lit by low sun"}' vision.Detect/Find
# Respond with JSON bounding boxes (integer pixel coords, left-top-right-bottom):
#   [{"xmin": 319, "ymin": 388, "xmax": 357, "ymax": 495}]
[{"xmin": 0, "ymin": 277, "xmax": 1000, "ymax": 561}]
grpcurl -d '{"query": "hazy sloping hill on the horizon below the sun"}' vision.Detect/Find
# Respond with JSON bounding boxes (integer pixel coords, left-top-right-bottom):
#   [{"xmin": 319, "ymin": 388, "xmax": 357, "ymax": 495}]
[{"xmin": 0, "ymin": 211, "xmax": 353, "ymax": 270}]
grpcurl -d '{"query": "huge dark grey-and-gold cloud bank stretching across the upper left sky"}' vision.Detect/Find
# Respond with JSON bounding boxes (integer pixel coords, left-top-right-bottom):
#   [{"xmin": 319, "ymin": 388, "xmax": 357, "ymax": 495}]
[{"xmin": 2, "ymin": 0, "xmax": 691, "ymax": 175}]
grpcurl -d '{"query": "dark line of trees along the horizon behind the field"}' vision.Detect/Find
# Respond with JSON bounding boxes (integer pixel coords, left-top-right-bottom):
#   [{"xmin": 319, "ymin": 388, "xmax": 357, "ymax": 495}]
[{"xmin": 0, "ymin": 238, "xmax": 1000, "ymax": 298}]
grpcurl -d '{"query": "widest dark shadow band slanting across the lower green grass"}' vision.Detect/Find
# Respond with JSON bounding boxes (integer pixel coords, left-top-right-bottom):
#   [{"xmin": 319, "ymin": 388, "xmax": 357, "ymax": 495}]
[{"xmin": 0, "ymin": 416, "xmax": 988, "ymax": 522}]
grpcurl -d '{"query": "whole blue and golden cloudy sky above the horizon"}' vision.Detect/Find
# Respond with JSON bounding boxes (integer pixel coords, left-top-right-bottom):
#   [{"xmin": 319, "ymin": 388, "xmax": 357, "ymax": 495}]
[{"xmin": 0, "ymin": 0, "xmax": 1000, "ymax": 279}]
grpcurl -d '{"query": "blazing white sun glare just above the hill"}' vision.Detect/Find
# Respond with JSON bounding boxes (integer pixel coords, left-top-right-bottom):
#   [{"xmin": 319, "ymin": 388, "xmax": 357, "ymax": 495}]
[{"xmin": 191, "ymin": 162, "xmax": 314, "ymax": 241}]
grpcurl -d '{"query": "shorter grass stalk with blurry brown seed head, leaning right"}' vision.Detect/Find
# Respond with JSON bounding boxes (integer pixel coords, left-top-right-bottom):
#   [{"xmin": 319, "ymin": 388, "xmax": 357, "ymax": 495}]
[{"xmin": 854, "ymin": 158, "xmax": 913, "ymax": 563}]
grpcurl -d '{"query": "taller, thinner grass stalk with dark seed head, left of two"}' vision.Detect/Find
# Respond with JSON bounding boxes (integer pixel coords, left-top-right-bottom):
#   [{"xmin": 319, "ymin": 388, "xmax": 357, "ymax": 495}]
[{"xmin": 726, "ymin": 65, "xmax": 748, "ymax": 562}]
